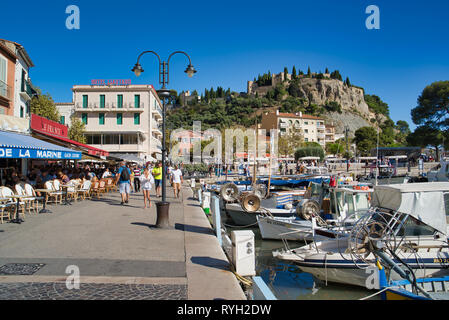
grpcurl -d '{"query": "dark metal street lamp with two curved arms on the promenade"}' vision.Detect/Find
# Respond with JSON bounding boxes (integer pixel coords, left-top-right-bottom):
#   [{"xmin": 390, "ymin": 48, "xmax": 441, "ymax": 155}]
[{"xmin": 131, "ymin": 51, "xmax": 196, "ymax": 228}]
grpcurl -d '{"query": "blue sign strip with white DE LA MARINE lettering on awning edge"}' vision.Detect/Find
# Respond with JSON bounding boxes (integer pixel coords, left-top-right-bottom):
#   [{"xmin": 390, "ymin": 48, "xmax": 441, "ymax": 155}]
[{"xmin": 0, "ymin": 148, "xmax": 81, "ymax": 160}]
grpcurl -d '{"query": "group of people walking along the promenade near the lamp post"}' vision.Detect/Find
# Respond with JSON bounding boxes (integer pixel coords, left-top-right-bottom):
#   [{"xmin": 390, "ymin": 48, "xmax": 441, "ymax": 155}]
[{"xmin": 115, "ymin": 161, "xmax": 183, "ymax": 209}]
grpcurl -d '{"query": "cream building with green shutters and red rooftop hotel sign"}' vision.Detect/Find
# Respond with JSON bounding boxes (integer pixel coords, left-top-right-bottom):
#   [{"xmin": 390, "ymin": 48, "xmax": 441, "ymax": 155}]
[{"xmin": 56, "ymin": 81, "xmax": 162, "ymax": 160}]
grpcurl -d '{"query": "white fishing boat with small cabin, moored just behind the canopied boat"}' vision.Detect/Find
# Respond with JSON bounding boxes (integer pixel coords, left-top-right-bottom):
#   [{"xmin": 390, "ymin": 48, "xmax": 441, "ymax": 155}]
[{"xmin": 257, "ymin": 186, "xmax": 373, "ymax": 241}]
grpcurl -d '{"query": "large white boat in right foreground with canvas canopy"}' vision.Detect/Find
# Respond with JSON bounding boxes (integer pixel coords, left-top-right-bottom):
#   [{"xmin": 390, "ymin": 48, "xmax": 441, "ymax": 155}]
[{"xmin": 273, "ymin": 182, "xmax": 449, "ymax": 287}]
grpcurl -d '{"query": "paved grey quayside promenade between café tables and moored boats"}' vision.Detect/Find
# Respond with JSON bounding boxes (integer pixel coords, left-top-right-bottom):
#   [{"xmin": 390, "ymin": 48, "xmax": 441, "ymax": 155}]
[{"xmin": 0, "ymin": 187, "xmax": 246, "ymax": 300}]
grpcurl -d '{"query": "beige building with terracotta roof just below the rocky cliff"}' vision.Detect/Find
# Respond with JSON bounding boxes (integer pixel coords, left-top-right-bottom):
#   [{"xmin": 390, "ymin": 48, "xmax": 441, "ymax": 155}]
[{"xmin": 260, "ymin": 110, "xmax": 332, "ymax": 148}]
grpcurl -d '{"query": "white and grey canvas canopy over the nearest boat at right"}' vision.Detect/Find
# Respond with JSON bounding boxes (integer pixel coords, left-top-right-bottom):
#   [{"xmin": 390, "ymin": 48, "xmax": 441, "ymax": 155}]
[{"xmin": 371, "ymin": 182, "xmax": 449, "ymax": 234}]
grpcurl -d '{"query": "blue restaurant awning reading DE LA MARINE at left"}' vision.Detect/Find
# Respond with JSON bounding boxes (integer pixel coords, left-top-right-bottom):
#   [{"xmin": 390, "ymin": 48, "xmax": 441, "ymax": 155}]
[{"xmin": 0, "ymin": 131, "xmax": 81, "ymax": 160}]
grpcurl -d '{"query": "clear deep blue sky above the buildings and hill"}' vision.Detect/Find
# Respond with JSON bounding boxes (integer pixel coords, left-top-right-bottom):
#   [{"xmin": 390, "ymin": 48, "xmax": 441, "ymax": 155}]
[{"xmin": 0, "ymin": 0, "xmax": 449, "ymax": 128}]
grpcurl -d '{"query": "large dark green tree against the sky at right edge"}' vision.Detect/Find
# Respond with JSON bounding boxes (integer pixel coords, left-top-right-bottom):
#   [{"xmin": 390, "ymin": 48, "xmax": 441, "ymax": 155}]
[{"xmin": 411, "ymin": 81, "xmax": 449, "ymax": 130}]
